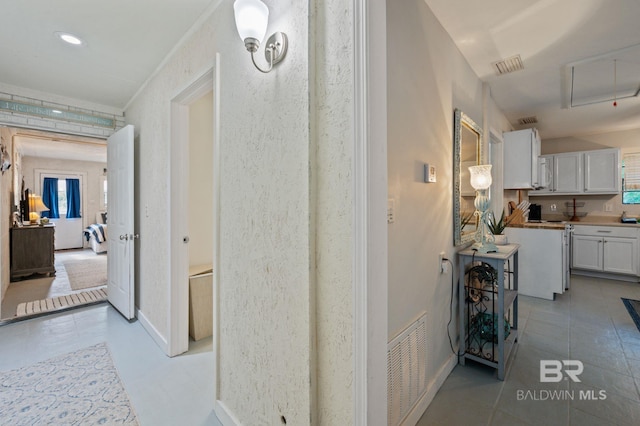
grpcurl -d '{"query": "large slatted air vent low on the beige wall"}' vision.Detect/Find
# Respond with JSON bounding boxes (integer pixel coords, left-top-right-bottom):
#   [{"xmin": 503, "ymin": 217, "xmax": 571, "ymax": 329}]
[{"xmin": 387, "ymin": 314, "xmax": 427, "ymax": 426}]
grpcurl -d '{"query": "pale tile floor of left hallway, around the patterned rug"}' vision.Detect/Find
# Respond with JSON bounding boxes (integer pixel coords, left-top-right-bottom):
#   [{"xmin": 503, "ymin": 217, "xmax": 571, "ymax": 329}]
[{"xmin": 0, "ymin": 304, "xmax": 221, "ymax": 426}]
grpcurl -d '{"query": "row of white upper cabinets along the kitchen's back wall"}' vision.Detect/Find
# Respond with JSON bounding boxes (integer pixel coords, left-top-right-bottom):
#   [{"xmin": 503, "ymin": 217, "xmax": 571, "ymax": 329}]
[{"xmin": 529, "ymin": 148, "xmax": 622, "ymax": 196}]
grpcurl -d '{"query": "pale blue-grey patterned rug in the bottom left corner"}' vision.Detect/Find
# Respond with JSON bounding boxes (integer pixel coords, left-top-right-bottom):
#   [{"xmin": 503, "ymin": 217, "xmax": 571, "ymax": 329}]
[{"xmin": 0, "ymin": 343, "xmax": 138, "ymax": 426}]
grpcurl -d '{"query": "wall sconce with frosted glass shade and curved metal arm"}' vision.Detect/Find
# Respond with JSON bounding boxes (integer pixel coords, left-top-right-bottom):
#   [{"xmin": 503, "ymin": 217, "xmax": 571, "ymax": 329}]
[{"xmin": 233, "ymin": 0, "xmax": 287, "ymax": 74}]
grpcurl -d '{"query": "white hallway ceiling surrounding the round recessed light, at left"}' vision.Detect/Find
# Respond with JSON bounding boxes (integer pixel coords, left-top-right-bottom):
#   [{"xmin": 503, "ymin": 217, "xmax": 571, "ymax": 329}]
[{"xmin": 0, "ymin": 0, "xmax": 214, "ymax": 109}]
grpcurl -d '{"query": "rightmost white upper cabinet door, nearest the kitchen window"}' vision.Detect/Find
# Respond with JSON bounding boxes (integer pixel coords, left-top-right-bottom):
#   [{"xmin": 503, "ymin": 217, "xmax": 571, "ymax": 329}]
[{"xmin": 584, "ymin": 149, "xmax": 621, "ymax": 194}]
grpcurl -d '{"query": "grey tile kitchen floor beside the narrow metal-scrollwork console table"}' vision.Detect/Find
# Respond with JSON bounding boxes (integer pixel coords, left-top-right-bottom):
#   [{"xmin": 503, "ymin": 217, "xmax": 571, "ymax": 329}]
[{"xmin": 418, "ymin": 275, "xmax": 640, "ymax": 426}]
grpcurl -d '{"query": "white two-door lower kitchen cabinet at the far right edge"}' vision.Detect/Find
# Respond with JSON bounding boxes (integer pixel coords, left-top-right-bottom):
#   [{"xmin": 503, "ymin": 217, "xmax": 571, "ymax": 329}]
[{"xmin": 571, "ymin": 226, "xmax": 639, "ymax": 277}]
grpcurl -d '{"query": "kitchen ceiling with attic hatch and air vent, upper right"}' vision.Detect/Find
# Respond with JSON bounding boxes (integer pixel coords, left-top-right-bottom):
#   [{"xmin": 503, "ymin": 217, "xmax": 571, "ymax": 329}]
[{"xmin": 425, "ymin": 0, "xmax": 640, "ymax": 138}]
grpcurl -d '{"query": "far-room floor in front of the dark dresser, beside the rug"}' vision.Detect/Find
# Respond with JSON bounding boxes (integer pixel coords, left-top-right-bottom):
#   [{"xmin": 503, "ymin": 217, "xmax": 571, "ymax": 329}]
[{"xmin": 0, "ymin": 248, "xmax": 106, "ymax": 319}]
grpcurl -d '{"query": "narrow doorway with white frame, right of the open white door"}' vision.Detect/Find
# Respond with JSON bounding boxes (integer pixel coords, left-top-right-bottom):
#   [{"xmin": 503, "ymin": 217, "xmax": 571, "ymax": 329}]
[{"xmin": 167, "ymin": 68, "xmax": 217, "ymax": 356}]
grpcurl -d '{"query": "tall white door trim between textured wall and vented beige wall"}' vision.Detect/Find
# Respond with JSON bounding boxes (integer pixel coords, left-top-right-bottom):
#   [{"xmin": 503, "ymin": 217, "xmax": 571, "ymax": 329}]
[{"xmin": 352, "ymin": 0, "xmax": 388, "ymax": 426}]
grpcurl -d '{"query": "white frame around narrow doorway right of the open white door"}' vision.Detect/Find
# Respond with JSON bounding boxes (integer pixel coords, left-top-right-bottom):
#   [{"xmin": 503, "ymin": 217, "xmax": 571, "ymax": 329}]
[{"xmin": 167, "ymin": 63, "xmax": 220, "ymax": 356}]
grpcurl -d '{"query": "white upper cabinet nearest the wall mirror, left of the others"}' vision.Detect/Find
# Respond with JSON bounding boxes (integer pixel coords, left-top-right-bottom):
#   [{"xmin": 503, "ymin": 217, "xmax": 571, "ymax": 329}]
[{"xmin": 503, "ymin": 129, "xmax": 540, "ymax": 189}]
